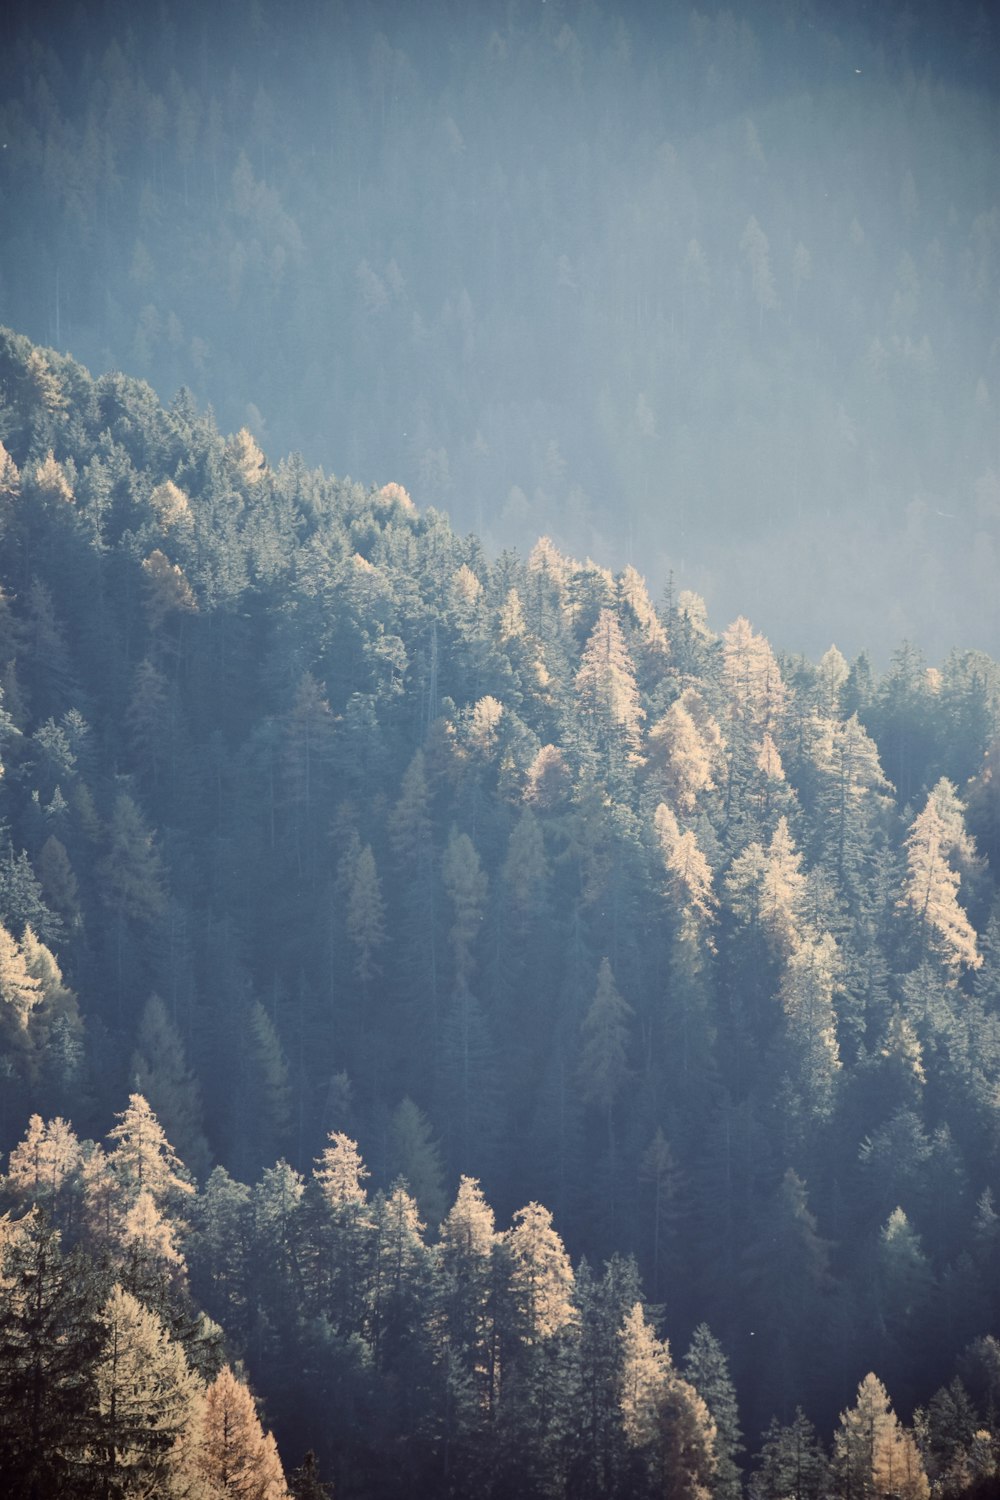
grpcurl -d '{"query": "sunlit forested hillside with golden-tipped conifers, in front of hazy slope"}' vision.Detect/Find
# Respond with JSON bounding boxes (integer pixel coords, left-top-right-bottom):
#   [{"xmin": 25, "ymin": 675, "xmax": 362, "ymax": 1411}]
[{"xmin": 0, "ymin": 322, "xmax": 1000, "ymax": 1500}]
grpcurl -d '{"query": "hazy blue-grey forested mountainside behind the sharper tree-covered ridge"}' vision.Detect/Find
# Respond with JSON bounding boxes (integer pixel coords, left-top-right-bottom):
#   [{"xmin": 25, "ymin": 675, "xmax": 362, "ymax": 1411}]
[{"xmin": 0, "ymin": 0, "xmax": 1000, "ymax": 663}]
